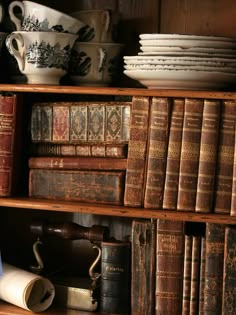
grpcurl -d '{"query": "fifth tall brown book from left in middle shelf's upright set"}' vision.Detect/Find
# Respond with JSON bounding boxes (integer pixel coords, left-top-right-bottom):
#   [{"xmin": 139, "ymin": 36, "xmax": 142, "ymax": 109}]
[{"xmin": 195, "ymin": 99, "xmax": 221, "ymax": 213}]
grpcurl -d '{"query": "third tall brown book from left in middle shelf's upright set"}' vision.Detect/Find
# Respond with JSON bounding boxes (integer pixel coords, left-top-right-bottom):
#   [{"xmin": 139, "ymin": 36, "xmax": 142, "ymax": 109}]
[{"xmin": 163, "ymin": 98, "xmax": 184, "ymax": 210}]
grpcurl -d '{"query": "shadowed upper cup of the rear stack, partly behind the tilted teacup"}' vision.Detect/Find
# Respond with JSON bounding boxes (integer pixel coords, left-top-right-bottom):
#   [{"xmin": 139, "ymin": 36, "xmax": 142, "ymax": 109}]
[{"xmin": 71, "ymin": 10, "xmax": 114, "ymax": 43}]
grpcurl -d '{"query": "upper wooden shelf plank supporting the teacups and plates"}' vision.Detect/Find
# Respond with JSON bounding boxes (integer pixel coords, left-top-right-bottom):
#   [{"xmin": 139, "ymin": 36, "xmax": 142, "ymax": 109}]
[{"xmin": 0, "ymin": 84, "xmax": 236, "ymax": 99}]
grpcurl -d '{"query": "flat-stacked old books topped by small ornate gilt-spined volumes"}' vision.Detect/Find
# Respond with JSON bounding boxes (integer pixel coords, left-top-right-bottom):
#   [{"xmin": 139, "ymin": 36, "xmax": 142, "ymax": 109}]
[{"xmin": 29, "ymin": 101, "xmax": 131, "ymax": 205}]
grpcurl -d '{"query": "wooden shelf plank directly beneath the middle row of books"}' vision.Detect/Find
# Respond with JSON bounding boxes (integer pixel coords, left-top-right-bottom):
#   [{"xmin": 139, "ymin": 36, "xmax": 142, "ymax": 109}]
[{"xmin": 0, "ymin": 198, "xmax": 236, "ymax": 224}]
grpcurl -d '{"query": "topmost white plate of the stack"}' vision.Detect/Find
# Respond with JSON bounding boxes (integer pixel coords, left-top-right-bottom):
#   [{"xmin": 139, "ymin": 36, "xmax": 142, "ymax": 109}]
[{"xmin": 139, "ymin": 33, "xmax": 236, "ymax": 42}]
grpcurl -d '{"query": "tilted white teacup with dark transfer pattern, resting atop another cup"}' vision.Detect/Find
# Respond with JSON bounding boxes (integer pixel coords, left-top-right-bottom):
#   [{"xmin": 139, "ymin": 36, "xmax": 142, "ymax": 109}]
[{"xmin": 8, "ymin": 0, "xmax": 84, "ymax": 34}]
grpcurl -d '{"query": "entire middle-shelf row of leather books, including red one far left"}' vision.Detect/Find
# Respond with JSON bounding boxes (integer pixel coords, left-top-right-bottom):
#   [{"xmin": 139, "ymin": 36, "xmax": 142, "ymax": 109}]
[{"xmin": 0, "ymin": 95, "xmax": 236, "ymax": 215}]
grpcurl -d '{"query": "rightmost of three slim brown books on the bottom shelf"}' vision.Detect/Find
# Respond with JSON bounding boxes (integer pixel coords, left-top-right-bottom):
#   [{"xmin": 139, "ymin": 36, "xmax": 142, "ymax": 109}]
[{"xmin": 198, "ymin": 236, "xmax": 206, "ymax": 315}]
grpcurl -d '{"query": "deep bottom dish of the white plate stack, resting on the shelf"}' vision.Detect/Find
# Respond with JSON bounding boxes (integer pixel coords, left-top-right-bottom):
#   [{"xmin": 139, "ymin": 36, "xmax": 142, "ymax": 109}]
[{"xmin": 124, "ymin": 70, "xmax": 236, "ymax": 90}]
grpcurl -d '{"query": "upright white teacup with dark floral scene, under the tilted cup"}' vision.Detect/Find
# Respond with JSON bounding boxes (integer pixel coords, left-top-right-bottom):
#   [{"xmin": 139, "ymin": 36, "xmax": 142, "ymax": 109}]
[{"xmin": 6, "ymin": 31, "xmax": 77, "ymax": 84}]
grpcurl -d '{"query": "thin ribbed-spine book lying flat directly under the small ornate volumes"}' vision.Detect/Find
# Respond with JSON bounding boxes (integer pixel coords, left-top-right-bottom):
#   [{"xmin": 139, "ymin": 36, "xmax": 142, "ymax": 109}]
[{"xmin": 30, "ymin": 143, "xmax": 128, "ymax": 158}]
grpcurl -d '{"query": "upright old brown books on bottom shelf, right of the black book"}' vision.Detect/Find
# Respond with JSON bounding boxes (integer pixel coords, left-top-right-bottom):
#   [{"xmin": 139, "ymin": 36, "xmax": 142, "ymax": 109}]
[{"xmin": 131, "ymin": 219, "xmax": 236, "ymax": 315}]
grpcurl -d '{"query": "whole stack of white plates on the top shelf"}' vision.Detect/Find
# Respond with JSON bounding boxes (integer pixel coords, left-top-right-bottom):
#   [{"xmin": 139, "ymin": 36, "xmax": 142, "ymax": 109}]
[{"xmin": 124, "ymin": 34, "xmax": 236, "ymax": 90}]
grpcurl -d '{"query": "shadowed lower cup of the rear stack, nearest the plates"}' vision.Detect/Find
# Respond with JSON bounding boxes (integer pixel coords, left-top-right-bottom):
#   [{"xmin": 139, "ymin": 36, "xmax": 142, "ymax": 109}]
[{"xmin": 68, "ymin": 41, "xmax": 123, "ymax": 86}]
